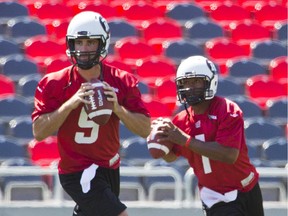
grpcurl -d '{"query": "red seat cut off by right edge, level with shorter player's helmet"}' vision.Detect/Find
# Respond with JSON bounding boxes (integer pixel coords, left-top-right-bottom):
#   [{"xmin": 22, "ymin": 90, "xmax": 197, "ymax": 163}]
[{"xmin": 268, "ymin": 56, "xmax": 288, "ymax": 80}]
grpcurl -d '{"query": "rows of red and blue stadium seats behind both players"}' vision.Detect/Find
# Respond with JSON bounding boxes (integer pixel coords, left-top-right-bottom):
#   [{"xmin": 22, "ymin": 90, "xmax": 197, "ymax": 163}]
[{"xmin": 0, "ymin": 0, "xmax": 288, "ymax": 202}]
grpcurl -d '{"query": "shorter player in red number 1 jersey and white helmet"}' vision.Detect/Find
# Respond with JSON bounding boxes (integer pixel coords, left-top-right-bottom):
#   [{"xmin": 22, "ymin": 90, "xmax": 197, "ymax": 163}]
[{"xmin": 152, "ymin": 56, "xmax": 264, "ymax": 216}]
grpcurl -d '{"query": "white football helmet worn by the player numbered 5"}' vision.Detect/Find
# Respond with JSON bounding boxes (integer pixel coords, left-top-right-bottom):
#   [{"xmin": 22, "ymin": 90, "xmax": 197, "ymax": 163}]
[{"xmin": 66, "ymin": 11, "xmax": 110, "ymax": 70}]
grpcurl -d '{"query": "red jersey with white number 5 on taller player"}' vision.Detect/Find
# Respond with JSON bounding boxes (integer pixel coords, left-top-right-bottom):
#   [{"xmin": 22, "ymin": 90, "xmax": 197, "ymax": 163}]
[{"xmin": 32, "ymin": 64, "xmax": 149, "ymax": 174}]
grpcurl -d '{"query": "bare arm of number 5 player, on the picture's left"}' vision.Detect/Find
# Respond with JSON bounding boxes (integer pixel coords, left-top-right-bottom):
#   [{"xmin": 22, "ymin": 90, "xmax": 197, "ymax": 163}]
[{"xmin": 32, "ymin": 83, "xmax": 93, "ymax": 141}]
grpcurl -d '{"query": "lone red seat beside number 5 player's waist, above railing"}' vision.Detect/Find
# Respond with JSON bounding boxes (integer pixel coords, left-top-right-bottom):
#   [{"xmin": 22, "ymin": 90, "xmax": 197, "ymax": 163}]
[{"xmin": 28, "ymin": 136, "xmax": 59, "ymax": 166}]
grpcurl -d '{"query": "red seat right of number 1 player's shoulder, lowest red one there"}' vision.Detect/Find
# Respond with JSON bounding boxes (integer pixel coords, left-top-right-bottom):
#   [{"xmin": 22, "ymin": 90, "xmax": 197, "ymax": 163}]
[{"xmin": 245, "ymin": 75, "xmax": 287, "ymax": 110}]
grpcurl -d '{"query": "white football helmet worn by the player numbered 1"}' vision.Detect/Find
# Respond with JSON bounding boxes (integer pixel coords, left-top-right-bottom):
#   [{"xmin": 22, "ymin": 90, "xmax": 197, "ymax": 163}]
[{"xmin": 175, "ymin": 56, "xmax": 218, "ymax": 105}]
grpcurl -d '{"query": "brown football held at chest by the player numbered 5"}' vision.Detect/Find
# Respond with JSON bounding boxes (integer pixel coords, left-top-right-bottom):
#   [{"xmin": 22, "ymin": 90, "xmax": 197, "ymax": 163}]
[{"xmin": 84, "ymin": 79, "xmax": 113, "ymax": 125}]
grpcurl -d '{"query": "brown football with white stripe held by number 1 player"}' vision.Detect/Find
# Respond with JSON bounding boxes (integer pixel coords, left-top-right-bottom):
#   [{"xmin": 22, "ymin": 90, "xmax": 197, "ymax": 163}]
[{"xmin": 147, "ymin": 127, "xmax": 173, "ymax": 159}]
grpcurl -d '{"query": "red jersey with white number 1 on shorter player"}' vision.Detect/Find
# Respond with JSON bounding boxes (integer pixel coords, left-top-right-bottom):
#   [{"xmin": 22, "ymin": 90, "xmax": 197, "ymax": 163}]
[{"xmin": 173, "ymin": 97, "xmax": 259, "ymax": 194}]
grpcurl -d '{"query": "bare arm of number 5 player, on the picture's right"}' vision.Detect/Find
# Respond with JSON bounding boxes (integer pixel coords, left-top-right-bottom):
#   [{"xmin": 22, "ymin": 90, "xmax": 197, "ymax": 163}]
[{"xmin": 104, "ymin": 82, "xmax": 151, "ymax": 138}]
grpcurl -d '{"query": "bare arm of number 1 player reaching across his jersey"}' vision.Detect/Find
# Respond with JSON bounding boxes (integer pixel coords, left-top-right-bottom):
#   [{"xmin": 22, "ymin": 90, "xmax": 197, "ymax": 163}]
[{"xmin": 155, "ymin": 119, "xmax": 239, "ymax": 164}]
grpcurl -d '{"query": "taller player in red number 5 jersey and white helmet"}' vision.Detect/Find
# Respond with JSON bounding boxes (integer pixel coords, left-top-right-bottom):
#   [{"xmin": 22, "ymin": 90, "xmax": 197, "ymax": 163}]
[{"xmin": 32, "ymin": 11, "xmax": 150, "ymax": 216}]
